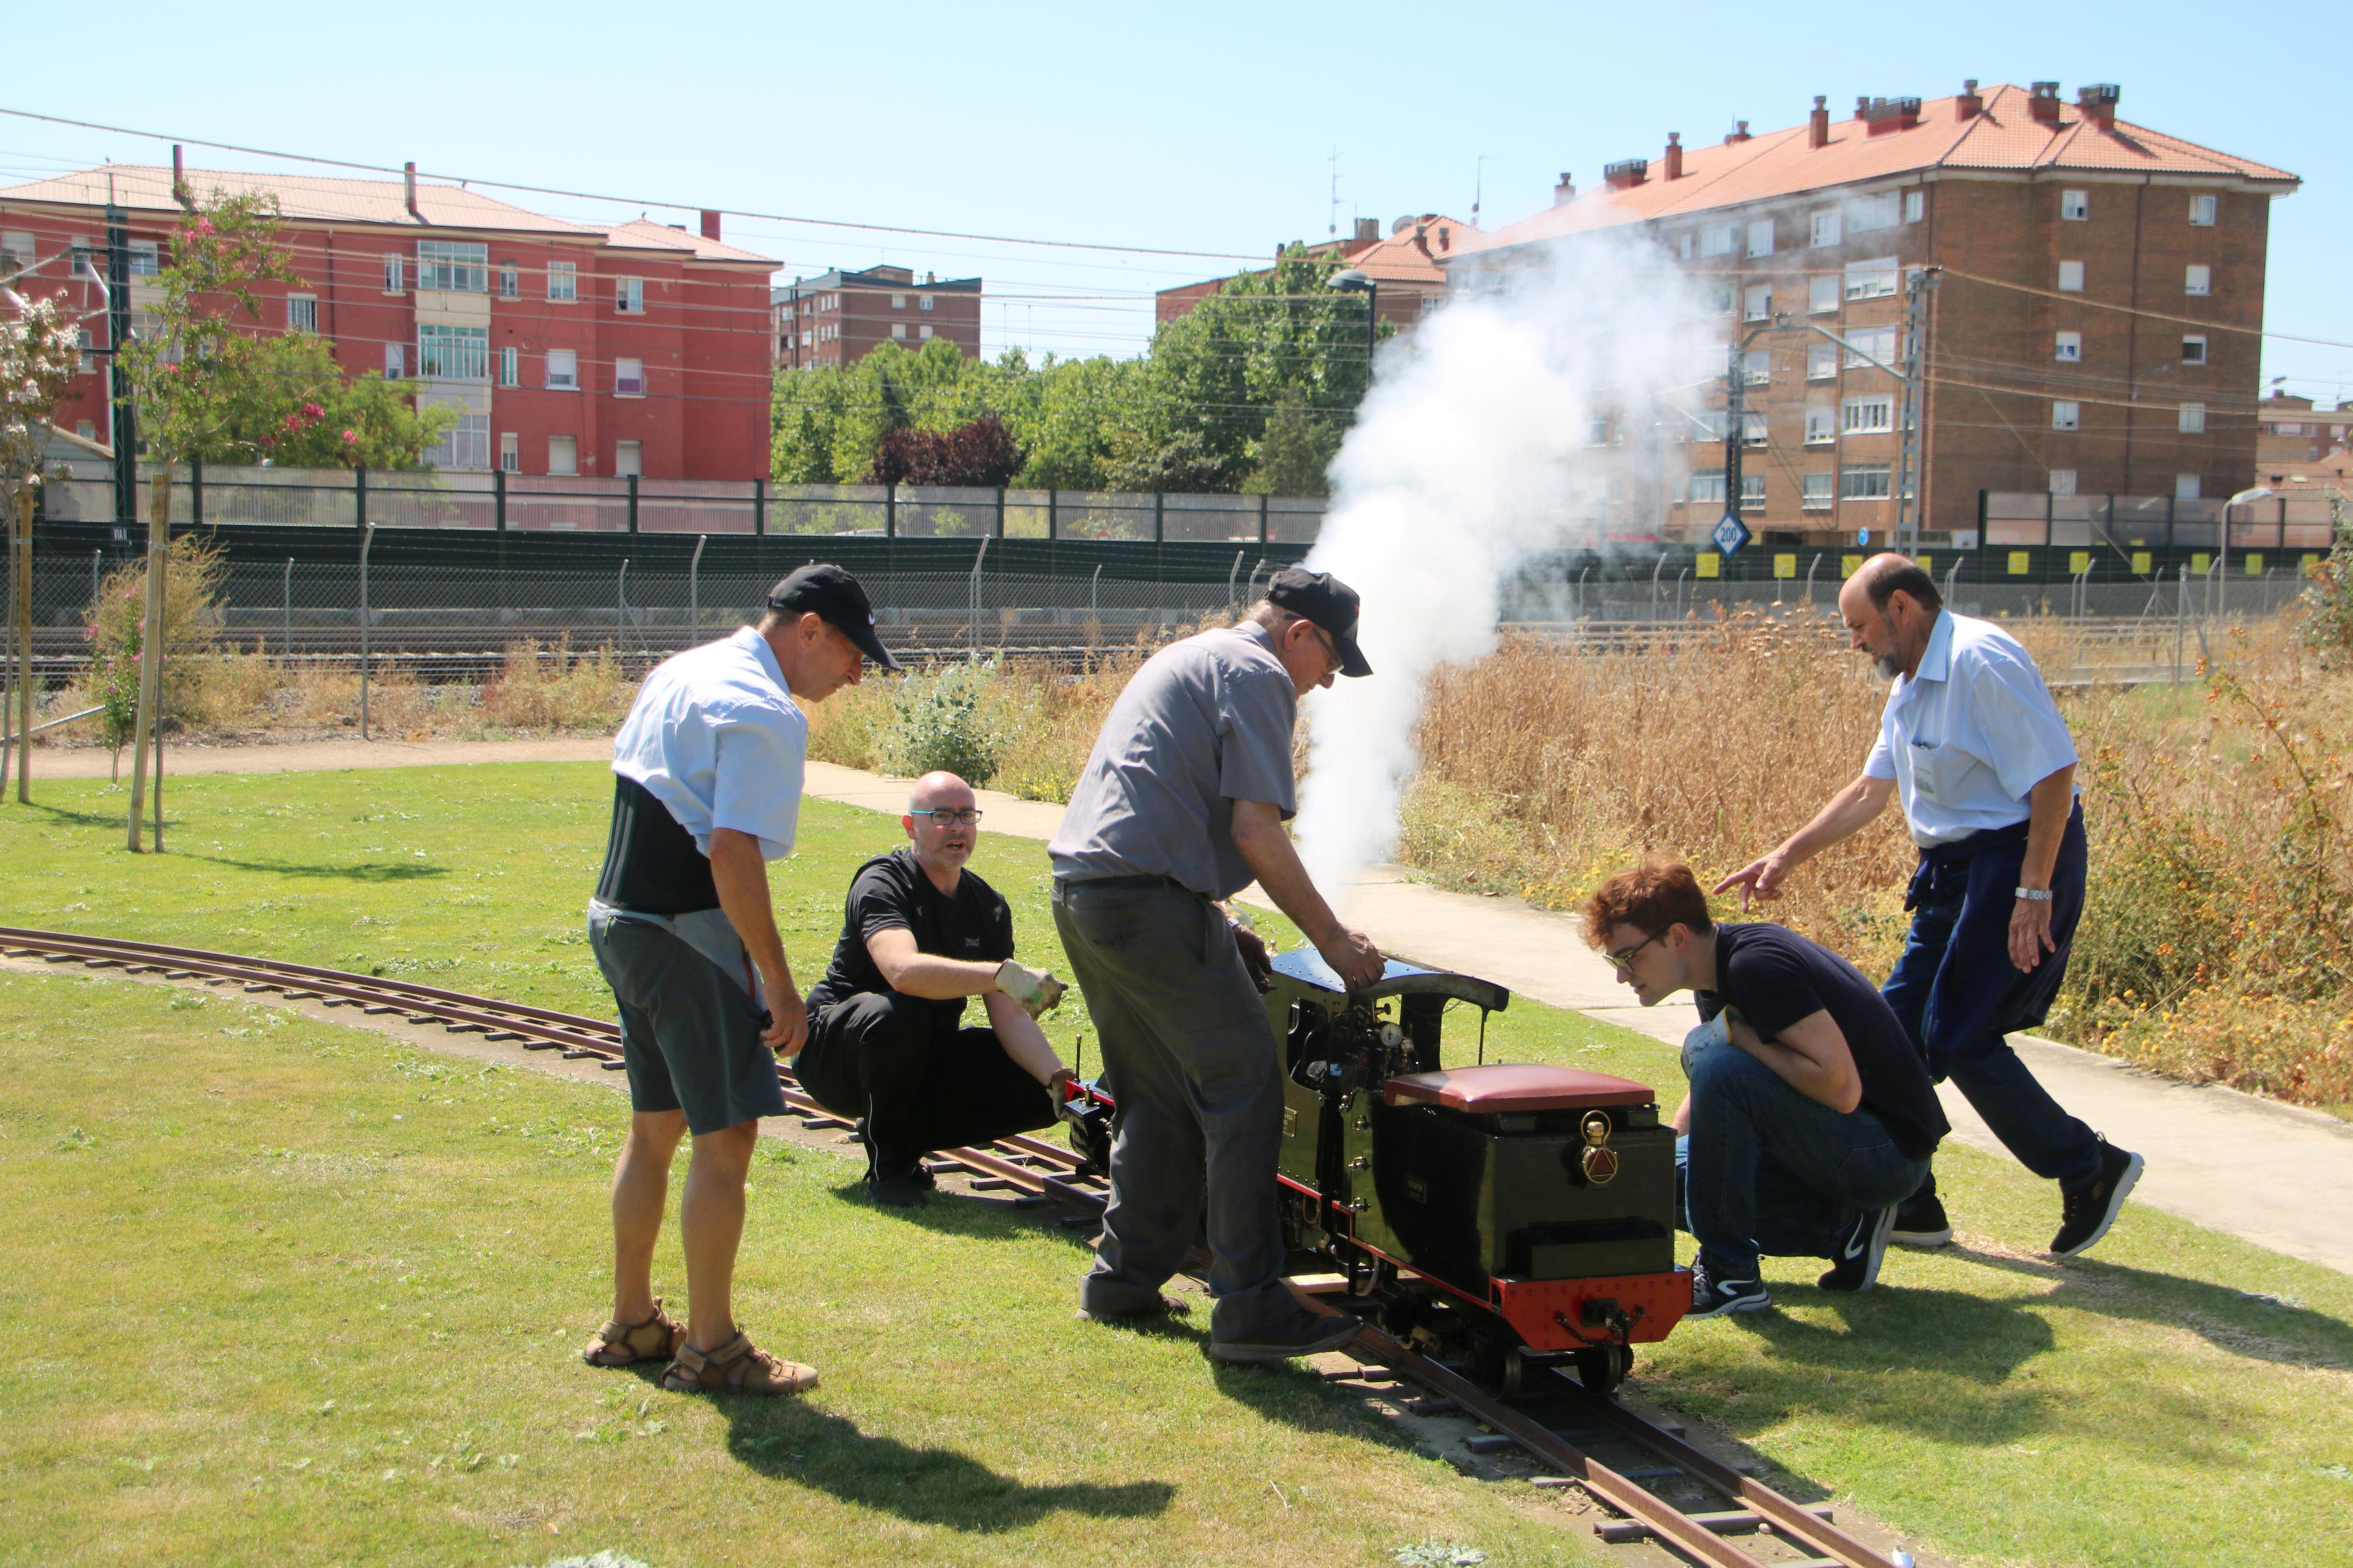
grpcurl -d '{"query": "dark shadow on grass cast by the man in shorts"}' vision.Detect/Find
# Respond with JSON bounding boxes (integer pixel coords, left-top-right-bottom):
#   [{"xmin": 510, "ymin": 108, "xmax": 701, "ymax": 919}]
[{"xmin": 722, "ymin": 1396, "xmax": 1177, "ymax": 1535}]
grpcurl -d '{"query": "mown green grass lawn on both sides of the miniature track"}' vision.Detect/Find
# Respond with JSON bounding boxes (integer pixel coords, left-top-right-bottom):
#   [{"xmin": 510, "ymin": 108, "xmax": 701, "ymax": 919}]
[{"xmin": 0, "ymin": 764, "xmax": 2353, "ymax": 1568}]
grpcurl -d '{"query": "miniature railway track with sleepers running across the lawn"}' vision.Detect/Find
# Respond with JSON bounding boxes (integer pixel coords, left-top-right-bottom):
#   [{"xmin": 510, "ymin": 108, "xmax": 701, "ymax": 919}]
[{"xmin": 0, "ymin": 926, "xmax": 1908, "ymax": 1568}]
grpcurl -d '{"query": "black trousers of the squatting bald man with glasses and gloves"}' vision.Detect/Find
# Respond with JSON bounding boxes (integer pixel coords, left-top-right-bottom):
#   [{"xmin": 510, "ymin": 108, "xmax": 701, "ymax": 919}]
[{"xmin": 793, "ymin": 992, "xmax": 1054, "ymax": 1175}]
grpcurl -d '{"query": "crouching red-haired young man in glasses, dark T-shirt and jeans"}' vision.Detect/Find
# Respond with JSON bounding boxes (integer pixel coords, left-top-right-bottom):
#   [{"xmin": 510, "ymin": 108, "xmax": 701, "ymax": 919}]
[{"xmin": 1586, "ymin": 865, "xmax": 1951, "ymax": 1317}]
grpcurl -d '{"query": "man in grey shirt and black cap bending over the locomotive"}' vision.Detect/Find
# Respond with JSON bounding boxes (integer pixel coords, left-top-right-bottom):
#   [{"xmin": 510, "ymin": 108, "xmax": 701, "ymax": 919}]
[{"xmin": 1047, "ymin": 567, "xmax": 1381, "ymax": 1361}]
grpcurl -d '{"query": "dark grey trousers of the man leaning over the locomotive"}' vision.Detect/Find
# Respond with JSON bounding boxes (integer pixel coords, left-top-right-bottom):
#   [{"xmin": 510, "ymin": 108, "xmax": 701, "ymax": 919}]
[{"xmin": 1054, "ymin": 877, "xmax": 1297, "ymax": 1342}]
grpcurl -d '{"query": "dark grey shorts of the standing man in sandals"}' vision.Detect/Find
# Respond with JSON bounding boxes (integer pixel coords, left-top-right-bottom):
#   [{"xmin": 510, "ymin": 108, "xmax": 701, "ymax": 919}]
[{"xmin": 588, "ymin": 919, "xmax": 783, "ymax": 1136}]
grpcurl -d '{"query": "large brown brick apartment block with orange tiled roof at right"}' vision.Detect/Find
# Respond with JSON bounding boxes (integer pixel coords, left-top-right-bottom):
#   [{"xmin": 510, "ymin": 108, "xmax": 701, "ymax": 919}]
[{"xmin": 1447, "ymin": 82, "xmax": 2299, "ymax": 543}]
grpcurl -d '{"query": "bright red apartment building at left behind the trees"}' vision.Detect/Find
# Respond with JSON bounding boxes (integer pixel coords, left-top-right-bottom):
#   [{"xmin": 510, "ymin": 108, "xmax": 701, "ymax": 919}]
[{"xmin": 0, "ymin": 165, "xmax": 776, "ymax": 479}]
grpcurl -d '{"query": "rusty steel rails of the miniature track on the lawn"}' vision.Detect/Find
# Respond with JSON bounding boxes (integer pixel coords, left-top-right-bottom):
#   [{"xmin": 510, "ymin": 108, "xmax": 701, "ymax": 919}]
[{"xmin": 0, "ymin": 926, "xmax": 1894, "ymax": 1568}]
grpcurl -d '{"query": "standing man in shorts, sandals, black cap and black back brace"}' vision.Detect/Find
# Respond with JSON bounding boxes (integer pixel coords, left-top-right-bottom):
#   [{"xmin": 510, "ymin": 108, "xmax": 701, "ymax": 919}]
[{"xmin": 581, "ymin": 564, "xmax": 899, "ymax": 1394}]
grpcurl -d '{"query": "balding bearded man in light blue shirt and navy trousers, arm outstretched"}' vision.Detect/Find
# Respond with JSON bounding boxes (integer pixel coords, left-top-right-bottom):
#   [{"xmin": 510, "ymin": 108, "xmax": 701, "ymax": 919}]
[{"xmin": 1715, "ymin": 555, "xmax": 2141, "ymax": 1258}]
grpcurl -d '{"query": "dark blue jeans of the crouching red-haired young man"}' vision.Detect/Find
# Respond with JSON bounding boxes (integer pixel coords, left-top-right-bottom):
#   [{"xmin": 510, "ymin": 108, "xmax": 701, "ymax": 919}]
[{"xmin": 1676, "ymin": 1021, "xmax": 1927, "ymax": 1279}]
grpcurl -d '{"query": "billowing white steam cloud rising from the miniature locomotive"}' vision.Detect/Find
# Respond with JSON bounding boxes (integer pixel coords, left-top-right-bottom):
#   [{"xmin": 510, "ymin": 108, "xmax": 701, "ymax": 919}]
[{"xmin": 1297, "ymin": 235, "xmax": 1722, "ymax": 905}]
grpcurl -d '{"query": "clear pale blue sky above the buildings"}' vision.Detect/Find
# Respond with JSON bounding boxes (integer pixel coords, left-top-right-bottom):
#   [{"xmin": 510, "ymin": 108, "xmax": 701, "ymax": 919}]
[{"xmin": 0, "ymin": 0, "xmax": 2353, "ymax": 402}]
